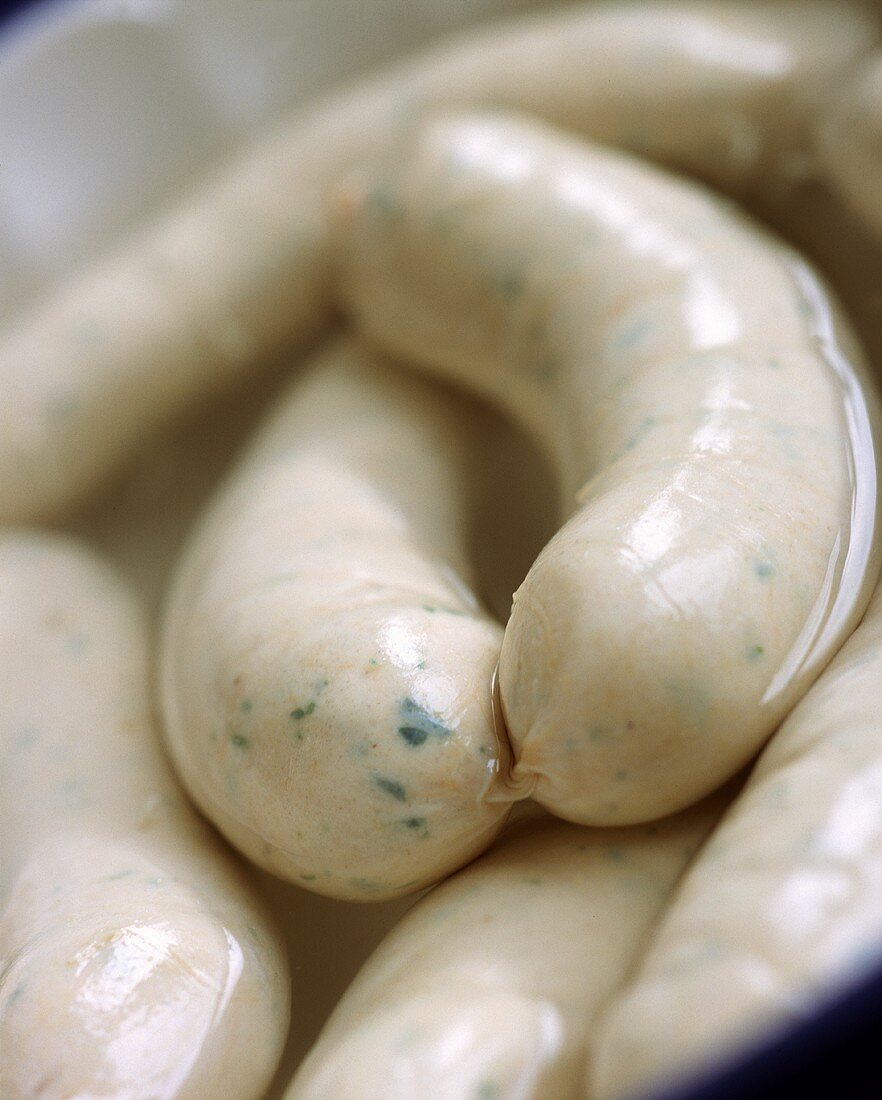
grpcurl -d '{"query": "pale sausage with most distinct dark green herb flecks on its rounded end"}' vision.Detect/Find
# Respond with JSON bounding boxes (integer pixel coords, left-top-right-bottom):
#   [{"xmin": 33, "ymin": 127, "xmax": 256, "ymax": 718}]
[{"xmin": 162, "ymin": 341, "xmax": 507, "ymax": 901}]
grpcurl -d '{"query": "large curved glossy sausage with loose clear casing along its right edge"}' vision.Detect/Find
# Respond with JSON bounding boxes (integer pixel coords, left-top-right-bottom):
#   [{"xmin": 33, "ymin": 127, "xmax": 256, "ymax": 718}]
[{"xmin": 340, "ymin": 116, "xmax": 879, "ymax": 824}]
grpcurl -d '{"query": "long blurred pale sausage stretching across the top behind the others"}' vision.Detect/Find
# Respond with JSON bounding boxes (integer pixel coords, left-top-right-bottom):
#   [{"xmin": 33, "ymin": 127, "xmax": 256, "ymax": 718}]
[{"xmin": 0, "ymin": 0, "xmax": 877, "ymax": 520}]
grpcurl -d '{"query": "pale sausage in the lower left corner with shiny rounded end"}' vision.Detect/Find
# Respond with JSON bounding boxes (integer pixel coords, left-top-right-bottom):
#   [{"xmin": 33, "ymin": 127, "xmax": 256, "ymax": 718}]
[{"xmin": 0, "ymin": 532, "xmax": 289, "ymax": 1100}]
